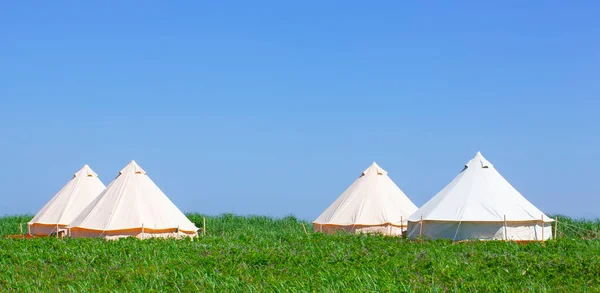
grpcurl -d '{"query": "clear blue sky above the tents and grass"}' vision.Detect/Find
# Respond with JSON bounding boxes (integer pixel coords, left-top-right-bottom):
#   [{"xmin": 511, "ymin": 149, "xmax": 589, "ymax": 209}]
[{"xmin": 0, "ymin": 1, "xmax": 600, "ymax": 220}]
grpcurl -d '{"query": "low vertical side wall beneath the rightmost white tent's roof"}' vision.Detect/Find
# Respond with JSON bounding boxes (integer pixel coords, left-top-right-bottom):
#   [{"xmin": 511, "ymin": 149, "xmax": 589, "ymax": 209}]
[{"xmin": 407, "ymin": 220, "xmax": 552, "ymax": 241}]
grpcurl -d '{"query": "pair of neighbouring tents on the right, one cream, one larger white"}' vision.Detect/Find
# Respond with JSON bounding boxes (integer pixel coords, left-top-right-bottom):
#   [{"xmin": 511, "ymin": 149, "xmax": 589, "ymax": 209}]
[{"xmin": 313, "ymin": 152, "xmax": 553, "ymax": 241}]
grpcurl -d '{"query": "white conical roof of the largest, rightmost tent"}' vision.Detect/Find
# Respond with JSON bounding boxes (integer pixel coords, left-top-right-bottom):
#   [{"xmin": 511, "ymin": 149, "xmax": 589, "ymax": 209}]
[{"xmin": 409, "ymin": 152, "xmax": 552, "ymax": 222}]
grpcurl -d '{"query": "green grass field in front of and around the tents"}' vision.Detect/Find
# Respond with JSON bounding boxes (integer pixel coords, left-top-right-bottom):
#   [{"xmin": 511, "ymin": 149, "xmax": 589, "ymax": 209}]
[{"xmin": 0, "ymin": 214, "xmax": 600, "ymax": 292}]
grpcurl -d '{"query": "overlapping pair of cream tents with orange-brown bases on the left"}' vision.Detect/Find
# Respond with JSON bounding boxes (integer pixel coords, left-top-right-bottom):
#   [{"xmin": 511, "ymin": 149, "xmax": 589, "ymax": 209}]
[{"xmin": 28, "ymin": 161, "xmax": 198, "ymax": 239}]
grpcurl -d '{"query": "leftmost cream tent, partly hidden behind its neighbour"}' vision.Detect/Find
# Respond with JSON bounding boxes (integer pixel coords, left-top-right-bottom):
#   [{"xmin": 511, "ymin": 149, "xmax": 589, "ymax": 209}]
[{"xmin": 28, "ymin": 165, "xmax": 105, "ymax": 235}]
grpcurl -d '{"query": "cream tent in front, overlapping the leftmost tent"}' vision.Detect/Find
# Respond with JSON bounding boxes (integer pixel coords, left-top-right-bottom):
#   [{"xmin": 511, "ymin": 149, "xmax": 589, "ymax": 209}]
[{"xmin": 70, "ymin": 161, "xmax": 198, "ymax": 239}]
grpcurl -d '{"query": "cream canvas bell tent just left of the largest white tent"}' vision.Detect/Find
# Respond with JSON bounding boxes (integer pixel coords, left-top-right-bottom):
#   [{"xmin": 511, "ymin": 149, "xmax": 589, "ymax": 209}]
[{"xmin": 313, "ymin": 163, "xmax": 417, "ymax": 235}]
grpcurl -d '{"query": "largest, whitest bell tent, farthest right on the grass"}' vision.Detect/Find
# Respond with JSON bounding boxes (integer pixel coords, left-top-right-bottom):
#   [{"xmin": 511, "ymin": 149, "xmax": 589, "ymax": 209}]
[{"xmin": 408, "ymin": 152, "xmax": 553, "ymax": 241}]
